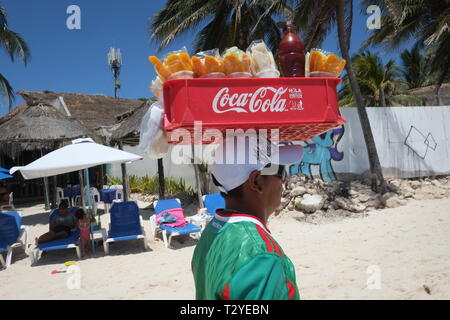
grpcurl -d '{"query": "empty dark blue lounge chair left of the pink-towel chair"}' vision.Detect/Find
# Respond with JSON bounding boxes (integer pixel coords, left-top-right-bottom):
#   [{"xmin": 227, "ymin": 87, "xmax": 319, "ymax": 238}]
[{"xmin": 104, "ymin": 201, "xmax": 149, "ymax": 254}]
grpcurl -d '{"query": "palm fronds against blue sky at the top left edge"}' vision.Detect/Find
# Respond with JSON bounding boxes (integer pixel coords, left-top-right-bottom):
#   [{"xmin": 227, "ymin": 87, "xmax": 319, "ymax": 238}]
[{"xmin": 0, "ymin": 5, "xmax": 30, "ymax": 111}]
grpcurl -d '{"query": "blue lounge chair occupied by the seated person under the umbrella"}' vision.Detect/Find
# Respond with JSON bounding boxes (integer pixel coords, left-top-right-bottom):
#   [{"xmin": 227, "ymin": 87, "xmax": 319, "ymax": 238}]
[{"xmin": 30, "ymin": 207, "xmax": 81, "ymax": 264}]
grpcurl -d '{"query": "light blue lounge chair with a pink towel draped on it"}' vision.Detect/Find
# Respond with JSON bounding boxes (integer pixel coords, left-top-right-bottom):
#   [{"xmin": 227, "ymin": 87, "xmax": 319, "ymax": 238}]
[{"xmin": 150, "ymin": 198, "xmax": 202, "ymax": 248}]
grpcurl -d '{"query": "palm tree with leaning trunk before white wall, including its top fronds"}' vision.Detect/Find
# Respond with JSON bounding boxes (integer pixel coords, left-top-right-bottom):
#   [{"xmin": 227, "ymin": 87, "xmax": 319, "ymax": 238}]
[{"xmin": 294, "ymin": 0, "xmax": 388, "ymax": 193}]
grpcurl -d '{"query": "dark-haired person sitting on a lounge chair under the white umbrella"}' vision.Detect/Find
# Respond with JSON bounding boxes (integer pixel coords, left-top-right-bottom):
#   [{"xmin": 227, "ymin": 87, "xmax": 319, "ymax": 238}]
[{"xmin": 36, "ymin": 200, "xmax": 78, "ymax": 245}]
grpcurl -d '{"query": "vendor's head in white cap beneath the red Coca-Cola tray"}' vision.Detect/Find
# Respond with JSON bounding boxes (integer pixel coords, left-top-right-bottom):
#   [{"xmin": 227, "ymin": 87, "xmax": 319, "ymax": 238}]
[{"xmin": 212, "ymin": 135, "xmax": 303, "ymax": 221}]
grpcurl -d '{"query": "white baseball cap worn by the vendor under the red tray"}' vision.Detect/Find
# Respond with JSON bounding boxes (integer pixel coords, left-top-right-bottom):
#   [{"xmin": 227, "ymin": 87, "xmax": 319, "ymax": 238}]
[{"xmin": 211, "ymin": 135, "xmax": 303, "ymax": 193}]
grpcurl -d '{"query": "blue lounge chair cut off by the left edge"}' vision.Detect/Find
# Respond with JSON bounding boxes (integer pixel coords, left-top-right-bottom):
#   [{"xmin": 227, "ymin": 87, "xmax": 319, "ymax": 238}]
[{"xmin": 0, "ymin": 211, "xmax": 28, "ymax": 268}]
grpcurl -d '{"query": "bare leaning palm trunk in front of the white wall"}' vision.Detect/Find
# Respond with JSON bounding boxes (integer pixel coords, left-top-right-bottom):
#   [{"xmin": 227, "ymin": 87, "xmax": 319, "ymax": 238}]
[{"xmin": 337, "ymin": 0, "xmax": 387, "ymax": 193}]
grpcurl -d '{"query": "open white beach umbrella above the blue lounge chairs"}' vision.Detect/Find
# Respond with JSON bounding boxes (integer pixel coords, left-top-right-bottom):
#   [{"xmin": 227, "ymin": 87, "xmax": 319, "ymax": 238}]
[{"xmin": 10, "ymin": 138, "xmax": 142, "ymax": 179}]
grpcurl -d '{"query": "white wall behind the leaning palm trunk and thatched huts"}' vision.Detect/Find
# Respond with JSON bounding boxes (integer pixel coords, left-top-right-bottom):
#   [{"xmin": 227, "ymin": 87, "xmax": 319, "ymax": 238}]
[{"xmin": 113, "ymin": 106, "xmax": 450, "ymax": 187}]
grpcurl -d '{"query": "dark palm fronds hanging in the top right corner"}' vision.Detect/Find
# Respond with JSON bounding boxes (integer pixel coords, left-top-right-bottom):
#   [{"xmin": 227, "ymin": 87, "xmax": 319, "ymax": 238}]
[{"xmin": 363, "ymin": 0, "xmax": 450, "ymax": 105}]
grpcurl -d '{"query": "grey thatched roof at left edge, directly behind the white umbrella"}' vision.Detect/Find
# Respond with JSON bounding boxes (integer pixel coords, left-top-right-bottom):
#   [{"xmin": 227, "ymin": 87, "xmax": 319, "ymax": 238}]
[{"xmin": 0, "ymin": 104, "xmax": 102, "ymax": 158}]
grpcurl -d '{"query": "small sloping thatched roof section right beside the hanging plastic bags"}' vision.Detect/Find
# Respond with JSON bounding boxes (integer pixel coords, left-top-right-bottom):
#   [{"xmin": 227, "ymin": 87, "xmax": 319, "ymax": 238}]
[{"xmin": 111, "ymin": 99, "xmax": 155, "ymax": 146}]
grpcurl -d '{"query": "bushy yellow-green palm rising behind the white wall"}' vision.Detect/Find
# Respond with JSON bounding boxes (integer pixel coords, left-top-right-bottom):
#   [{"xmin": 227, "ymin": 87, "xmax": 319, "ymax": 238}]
[{"xmin": 339, "ymin": 52, "xmax": 422, "ymax": 107}]
